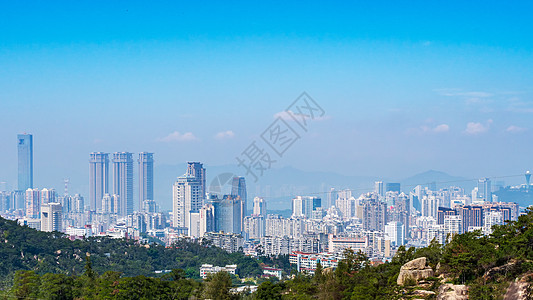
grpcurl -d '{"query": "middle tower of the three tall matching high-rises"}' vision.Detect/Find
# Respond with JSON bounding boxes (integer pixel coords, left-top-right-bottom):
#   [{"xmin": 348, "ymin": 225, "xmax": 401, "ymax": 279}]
[{"xmin": 113, "ymin": 152, "xmax": 133, "ymax": 216}]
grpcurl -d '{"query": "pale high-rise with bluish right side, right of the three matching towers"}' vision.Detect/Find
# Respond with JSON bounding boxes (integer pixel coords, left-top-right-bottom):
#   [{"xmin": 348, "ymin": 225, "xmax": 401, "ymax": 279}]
[{"xmin": 172, "ymin": 173, "xmax": 205, "ymax": 228}]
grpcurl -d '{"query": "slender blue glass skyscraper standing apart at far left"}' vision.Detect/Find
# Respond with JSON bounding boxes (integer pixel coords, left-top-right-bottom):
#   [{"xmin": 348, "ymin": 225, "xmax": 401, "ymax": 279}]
[{"xmin": 17, "ymin": 133, "xmax": 33, "ymax": 191}]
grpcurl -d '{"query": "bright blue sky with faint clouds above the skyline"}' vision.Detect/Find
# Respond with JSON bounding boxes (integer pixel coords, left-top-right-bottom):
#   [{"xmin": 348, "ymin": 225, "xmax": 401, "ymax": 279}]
[{"xmin": 0, "ymin": 1, "xmax": 533, "ymax": 199}]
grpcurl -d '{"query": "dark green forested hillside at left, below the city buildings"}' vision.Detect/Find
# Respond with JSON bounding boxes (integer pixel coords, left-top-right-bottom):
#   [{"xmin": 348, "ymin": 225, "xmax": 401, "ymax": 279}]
[{"xmin": 0, "ymin": 218, "xmax": 262, "ymax": 285}]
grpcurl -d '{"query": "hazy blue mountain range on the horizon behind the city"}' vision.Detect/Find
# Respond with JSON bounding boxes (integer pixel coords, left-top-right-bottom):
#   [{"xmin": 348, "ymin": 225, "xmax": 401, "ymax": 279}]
[{"xmin": 154, "ymin": 163, "xmax": 476, "ymax": 210}]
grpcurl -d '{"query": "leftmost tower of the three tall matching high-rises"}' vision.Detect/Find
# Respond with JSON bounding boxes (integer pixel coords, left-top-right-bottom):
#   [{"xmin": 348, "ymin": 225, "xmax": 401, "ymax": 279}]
[{"xmin": 89, "ymin": 152, "xmax": 109, "ymax": 211}]
